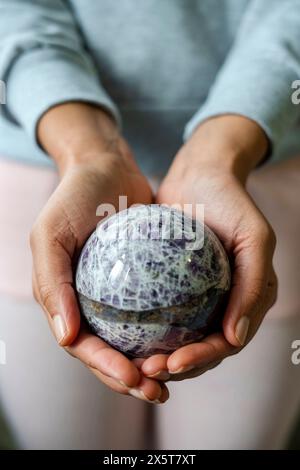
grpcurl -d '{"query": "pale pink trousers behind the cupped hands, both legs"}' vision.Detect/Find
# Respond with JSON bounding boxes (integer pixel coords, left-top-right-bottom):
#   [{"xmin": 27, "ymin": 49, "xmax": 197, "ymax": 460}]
[{"xmin": 0, "ymin": 159, "xmax": 300, "ymax": 449}]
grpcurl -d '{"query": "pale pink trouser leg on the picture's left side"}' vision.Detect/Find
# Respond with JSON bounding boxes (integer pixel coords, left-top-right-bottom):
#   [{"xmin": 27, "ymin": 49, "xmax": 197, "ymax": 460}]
[{"xmin": 0, "ymin": 161, "xmax": 147, "ymax": 449}]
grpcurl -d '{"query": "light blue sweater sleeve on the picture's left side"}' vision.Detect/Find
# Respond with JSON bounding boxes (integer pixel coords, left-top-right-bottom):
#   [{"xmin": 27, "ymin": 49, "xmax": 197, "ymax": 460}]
[{"xmin": 0, "ymin": 0, "xmax": 120, "ymax": 143}]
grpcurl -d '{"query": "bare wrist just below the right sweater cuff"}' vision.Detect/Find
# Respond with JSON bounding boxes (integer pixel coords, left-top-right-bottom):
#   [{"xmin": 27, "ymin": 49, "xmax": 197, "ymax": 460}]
[{"xmin": 185, "ymin": 115, "xmax": 269, "ymax": 182}]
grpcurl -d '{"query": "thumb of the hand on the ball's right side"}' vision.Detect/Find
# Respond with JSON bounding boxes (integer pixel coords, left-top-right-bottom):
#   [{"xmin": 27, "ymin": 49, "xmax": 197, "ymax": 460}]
[{"xmin": 223, "ymin": 222, "xmax": 275, "ymax": 346}]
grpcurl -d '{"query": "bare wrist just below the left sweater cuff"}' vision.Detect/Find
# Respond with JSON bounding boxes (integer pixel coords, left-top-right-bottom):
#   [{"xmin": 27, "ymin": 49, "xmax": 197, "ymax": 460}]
[{"xmin": 37, "ymin": 102, "xmax": 120, "ymax": 174}]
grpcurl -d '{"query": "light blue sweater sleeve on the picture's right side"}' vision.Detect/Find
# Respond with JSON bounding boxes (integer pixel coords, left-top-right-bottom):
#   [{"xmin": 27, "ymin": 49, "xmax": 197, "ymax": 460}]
[{"xmin": 184, "ymin": 0, "xmax": 300, "ymax": 157}]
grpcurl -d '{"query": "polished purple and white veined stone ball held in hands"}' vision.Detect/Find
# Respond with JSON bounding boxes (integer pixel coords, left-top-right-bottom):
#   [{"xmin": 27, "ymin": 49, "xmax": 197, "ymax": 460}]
[{"xmin": 76, "ymin": 204, "xmax": 230, "ymax": 357}]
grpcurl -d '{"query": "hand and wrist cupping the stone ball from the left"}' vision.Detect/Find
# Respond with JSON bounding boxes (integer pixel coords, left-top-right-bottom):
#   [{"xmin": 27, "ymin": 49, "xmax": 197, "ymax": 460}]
[{"xmin": 31, "ymin": 103, "xmax": 168, "ymax": 402}]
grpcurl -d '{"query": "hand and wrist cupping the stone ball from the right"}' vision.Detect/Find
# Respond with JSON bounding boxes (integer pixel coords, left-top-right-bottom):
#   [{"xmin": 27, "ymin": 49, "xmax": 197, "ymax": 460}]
[{"xmin": 140, "ymin": 116, "xmax": 277, "ymax": 380}]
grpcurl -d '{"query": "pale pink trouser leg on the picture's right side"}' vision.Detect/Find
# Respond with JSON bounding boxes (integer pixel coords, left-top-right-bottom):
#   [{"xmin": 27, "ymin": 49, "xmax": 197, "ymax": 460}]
[{"xmin": 157, "ymin": 159, "xmax": 300, "ymax": 449}]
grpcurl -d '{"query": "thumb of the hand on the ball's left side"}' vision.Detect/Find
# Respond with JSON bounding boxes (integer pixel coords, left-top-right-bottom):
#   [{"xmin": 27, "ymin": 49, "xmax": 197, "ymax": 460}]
[{"xmin": 31, "ymin": 219, "xmax": 80, "ymax": 346}]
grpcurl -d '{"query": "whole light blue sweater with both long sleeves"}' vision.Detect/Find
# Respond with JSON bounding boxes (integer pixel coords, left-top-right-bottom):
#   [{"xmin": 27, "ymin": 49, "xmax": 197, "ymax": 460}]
[{"xmin": 0, "ymin": 0, "xmax": 300, "ymax": 173}]
